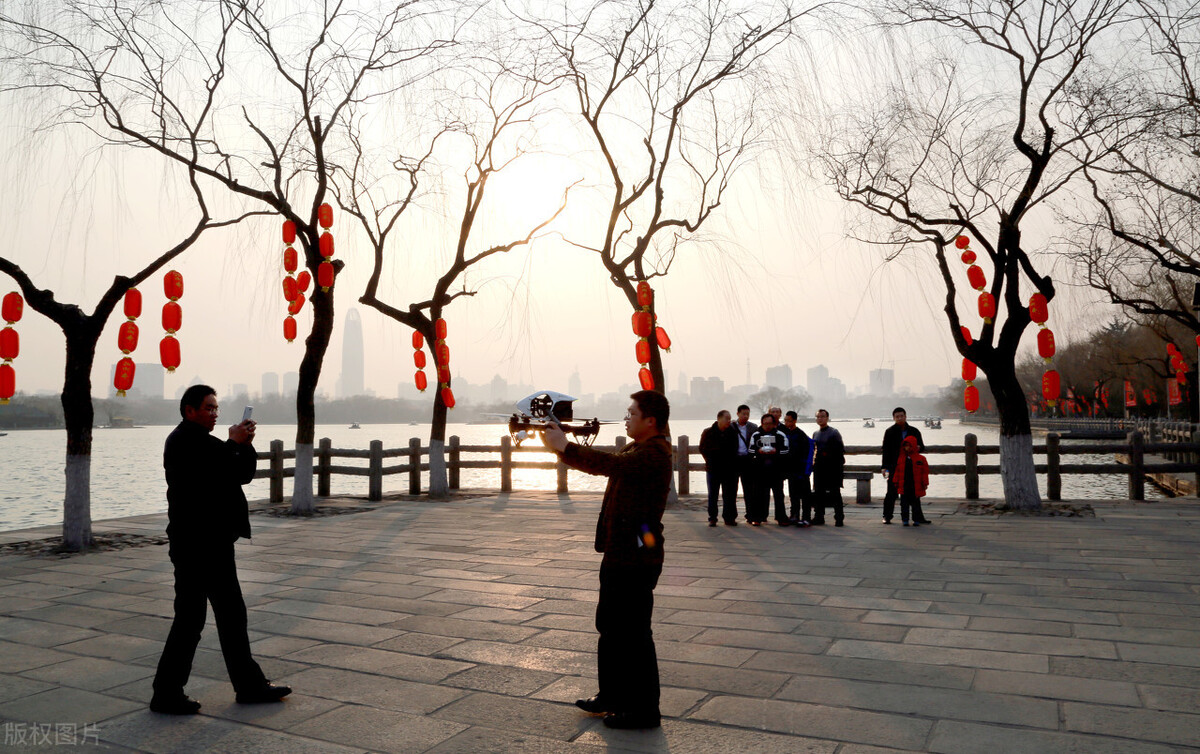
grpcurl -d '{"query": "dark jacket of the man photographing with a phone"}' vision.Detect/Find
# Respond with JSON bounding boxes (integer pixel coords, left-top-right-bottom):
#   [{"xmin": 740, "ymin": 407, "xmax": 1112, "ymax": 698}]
[{"xmin": 162, "ymin": 420, "xmax": 258, "ymax": 549}]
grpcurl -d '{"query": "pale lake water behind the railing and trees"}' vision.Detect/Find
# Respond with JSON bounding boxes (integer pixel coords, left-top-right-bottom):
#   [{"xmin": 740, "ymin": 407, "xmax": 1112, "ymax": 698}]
[{"xmin": 0, "ymin": 419, "xmax": 1158, "ymax": 531}]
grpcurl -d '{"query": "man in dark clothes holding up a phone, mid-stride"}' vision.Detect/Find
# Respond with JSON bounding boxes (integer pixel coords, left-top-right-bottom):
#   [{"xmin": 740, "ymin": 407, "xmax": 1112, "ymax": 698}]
[{"xmin": 150, "ymin": 385, "xmax": 292, "ymax": 714}]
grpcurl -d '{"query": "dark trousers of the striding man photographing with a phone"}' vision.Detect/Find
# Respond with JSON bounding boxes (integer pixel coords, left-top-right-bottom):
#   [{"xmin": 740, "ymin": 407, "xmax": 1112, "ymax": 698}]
[{"xmin": 154, "ymin": 543, "xmax": 266, "ymax": 696}]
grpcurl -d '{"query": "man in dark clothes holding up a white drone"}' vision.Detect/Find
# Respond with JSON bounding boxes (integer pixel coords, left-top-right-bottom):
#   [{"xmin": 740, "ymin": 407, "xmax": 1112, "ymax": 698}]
[{"xmin": 542, "ymin": 390, "xmax": 671, "ymax": 728}]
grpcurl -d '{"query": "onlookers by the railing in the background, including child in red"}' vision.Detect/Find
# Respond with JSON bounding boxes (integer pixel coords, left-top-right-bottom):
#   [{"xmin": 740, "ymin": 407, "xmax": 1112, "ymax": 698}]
[{"xmin": 700, "ymin": 405, "xmax": 929, "ymax": 527}]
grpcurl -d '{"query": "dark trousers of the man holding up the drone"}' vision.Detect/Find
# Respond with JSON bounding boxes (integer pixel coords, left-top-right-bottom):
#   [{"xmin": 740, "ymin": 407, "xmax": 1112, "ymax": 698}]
[{"xmin": 596, "ymin": 561, "xmax": 662, "ymax": 714}]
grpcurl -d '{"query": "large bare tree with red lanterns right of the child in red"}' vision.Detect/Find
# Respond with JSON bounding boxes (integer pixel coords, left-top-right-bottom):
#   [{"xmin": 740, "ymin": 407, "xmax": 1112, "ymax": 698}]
[{"xmin": 820, "ymin": 0, "xmax": 1127, "ymax": 509}]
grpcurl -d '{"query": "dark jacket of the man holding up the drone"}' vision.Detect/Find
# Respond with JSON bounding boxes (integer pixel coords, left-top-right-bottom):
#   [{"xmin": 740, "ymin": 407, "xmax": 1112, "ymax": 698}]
[{"xmin": 563, "ymin": 435, "xmax": 671, "ymax": 566}]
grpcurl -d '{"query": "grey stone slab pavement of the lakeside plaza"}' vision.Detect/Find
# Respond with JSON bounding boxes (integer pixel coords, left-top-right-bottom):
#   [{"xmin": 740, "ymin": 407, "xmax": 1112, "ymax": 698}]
[{"xmin": 0, "ymin": 493, "xmax": 1200, "ymax": 754}]
